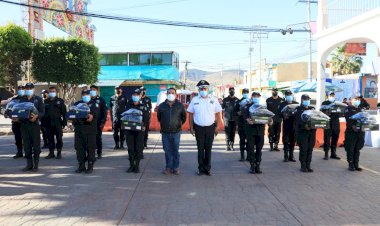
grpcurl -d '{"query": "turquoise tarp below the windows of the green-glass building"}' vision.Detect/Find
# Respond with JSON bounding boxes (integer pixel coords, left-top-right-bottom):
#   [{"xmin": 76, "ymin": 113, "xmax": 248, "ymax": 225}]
[{"xmin": 98, "ymin": 66, "xmax": 179, "ymax": 81}]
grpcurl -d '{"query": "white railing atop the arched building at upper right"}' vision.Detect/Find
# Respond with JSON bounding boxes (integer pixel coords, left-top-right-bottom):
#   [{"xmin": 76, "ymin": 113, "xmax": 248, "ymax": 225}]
[{"xmin": 325, "ymin": 0, "xmax": 380, "ymax": 28}]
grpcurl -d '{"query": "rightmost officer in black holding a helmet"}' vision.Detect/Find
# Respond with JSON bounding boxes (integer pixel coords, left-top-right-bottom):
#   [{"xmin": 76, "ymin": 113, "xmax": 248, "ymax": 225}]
[{"xmin": 344, "ymin": 95, "xmax": 365, "ymax": 171}]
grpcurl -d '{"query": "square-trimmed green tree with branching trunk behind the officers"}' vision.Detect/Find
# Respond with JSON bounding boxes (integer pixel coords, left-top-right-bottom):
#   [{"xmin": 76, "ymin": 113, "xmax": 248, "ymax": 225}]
[{"xmin": 32, "ymin": 38, "xmax": 100, "ymax": 105}]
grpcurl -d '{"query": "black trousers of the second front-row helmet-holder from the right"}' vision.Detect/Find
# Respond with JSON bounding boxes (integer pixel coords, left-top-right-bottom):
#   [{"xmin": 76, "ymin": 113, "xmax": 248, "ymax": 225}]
[{"xmin": 297, "ymin": 130, "xmax": 316, "ymax": 164}]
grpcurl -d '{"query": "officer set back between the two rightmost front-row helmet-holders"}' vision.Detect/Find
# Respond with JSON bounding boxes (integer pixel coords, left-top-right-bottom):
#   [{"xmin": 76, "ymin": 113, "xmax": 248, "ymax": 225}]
[{"xmin": 321, "ymin": 91, "xmax": 342, "ymax": 160}]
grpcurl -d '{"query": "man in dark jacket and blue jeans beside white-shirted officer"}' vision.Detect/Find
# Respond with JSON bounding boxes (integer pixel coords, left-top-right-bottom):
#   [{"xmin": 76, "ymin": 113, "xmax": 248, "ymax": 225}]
[{"xmin": 157, "ymin": 88, "xmax": 186, "ymax": 175}]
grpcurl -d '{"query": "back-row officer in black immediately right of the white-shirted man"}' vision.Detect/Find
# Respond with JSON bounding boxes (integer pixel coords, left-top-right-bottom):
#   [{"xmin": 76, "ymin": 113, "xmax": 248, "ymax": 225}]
[{"xmin": 222, "ymin": 87, "xmax": 239, "ymax": 151}]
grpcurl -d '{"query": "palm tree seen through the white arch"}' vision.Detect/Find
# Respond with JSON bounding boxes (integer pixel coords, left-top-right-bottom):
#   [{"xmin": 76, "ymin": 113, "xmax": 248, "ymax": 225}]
[{"xmin": 331, "ymin": 45, "xmax": 363, "ymax": 75}]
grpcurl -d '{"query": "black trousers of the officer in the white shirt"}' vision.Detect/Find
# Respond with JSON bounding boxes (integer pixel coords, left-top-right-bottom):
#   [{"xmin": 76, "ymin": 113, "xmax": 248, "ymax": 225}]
[{"xmin": 194, "ymin": 124, "xmax": 215, "ymax": 172}]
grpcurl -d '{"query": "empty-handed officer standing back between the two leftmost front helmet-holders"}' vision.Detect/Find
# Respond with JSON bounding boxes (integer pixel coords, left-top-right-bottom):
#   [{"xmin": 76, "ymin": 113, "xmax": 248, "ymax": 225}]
[{"xmin": 44, "ymin": 87, "xmax": 67, "ymax": 159}]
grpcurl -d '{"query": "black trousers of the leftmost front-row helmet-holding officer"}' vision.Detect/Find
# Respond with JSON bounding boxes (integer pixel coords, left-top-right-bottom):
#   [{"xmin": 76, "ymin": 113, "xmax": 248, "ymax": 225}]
[{"xmin": 21, "ymin": 122, "xmax": 41, "ymax": 160}]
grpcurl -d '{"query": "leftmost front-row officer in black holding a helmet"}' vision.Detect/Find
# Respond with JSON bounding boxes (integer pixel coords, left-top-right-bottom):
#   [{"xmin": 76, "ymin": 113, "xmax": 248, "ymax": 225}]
[{"xmin": 20, "ymin": 83, "xmax": 45, "ymax": 171}]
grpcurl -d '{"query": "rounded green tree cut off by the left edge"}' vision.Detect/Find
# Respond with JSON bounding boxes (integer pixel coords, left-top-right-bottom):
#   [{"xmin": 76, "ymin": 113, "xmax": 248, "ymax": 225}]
[{"xmin": 0, "ymin": 24, "xmax": 33, "ymax": 89}]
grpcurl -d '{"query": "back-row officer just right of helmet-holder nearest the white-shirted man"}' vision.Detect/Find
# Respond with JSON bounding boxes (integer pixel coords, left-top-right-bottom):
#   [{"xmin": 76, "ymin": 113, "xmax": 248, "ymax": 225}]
[{"xmin": 267, "ymin": 88, "xmax": 284, "ymax": 151}]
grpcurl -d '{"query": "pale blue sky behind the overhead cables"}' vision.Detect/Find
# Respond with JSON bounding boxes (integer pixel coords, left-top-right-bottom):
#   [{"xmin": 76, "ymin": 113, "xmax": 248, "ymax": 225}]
[{"xmin": 0, "ymin": 0, "xmax": 317, "ymax": 71}]
